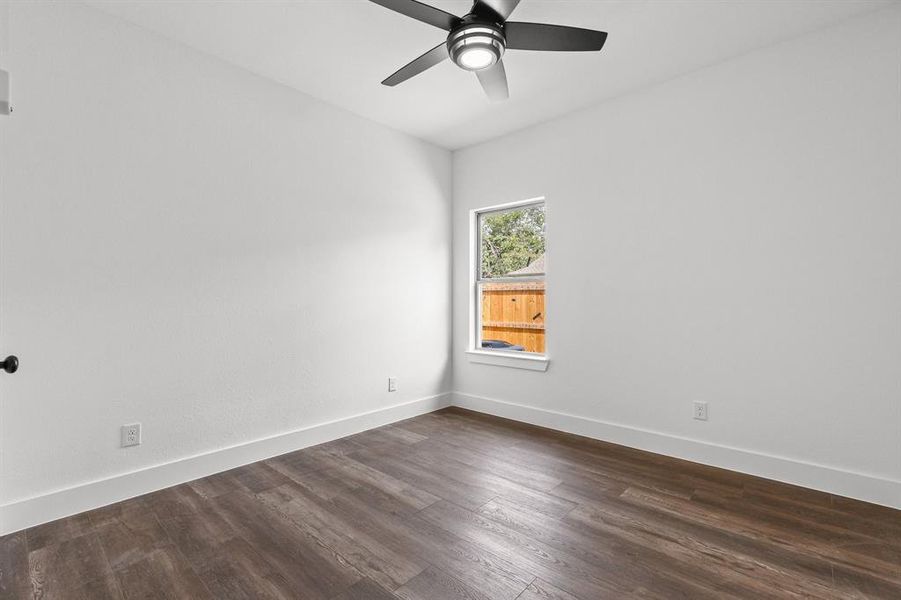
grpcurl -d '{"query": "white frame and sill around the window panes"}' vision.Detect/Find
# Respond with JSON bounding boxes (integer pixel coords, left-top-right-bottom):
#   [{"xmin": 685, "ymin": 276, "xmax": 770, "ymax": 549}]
[{"xmin": 466, "ymin": 196, "xmax": 550, "ymax": 371}]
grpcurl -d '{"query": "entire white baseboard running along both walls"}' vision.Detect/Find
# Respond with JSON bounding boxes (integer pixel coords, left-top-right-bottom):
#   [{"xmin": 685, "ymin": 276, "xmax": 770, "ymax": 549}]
[{"xmin": 0, "ymin": 392, "xmax": 901, "ymax": 535}]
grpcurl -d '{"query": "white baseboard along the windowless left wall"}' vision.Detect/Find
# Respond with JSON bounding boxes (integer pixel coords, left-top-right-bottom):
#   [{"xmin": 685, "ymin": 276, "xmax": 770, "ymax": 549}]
[{"xmin": 0, "ymin": 393, "xmax": 450, "ymax": 535}]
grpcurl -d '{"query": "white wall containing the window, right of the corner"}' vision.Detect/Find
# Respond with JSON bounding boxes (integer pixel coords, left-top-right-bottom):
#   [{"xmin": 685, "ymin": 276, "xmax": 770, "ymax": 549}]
[{"xmin": 454, "ymin": 8, "xmax": 901, "ymax": 508}]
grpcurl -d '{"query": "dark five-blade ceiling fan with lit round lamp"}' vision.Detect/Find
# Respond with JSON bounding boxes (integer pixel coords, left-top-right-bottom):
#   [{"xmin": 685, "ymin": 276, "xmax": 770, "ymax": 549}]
[{"xmin": 370, "ymin": 0, "xmax": 607, "ymax": 101}]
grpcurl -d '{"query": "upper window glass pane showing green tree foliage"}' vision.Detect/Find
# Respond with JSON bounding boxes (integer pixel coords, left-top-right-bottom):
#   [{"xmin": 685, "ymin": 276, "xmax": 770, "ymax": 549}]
[{"xmin": 479, "ymin": 204, "xmax": 545, "ymax": 279}]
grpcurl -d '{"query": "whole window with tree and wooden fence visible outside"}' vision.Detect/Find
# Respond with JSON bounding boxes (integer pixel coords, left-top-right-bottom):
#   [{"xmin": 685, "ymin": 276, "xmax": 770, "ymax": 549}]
[{"xmin": 472, "ymin": 199, "xmax": 547, "ymax": 368}]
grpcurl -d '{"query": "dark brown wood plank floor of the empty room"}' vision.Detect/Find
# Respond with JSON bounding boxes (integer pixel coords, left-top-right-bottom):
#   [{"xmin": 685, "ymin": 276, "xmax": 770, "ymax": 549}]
[{"xmin": 0, "ymin": 409, "xmax": 901, "ymax": 600}]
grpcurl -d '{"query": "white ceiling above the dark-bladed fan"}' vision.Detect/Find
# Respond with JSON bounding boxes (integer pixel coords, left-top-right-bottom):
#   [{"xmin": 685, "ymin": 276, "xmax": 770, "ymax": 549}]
[{"xmin": 88, "ymin": 0, "xmax": 893, "ymax": 149}]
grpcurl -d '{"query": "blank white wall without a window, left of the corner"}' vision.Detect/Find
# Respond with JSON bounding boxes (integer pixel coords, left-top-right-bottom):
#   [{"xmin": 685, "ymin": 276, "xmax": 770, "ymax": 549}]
[{"xmin": 0, "ymin": 3, "xmax": 451, "ymax": 528}]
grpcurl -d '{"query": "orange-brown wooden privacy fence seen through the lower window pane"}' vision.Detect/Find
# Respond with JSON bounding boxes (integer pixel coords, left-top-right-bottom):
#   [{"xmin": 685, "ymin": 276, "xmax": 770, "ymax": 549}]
[{"xmin": 482, "ymin": 281, "xmax": 544, "ymax": 352}]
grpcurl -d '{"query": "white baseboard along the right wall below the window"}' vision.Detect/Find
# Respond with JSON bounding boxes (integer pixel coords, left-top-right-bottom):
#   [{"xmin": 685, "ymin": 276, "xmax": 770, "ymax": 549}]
[{"xmin": 452, "ymin": 392, "xmax": 901, "ymax": 509}]
